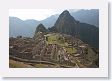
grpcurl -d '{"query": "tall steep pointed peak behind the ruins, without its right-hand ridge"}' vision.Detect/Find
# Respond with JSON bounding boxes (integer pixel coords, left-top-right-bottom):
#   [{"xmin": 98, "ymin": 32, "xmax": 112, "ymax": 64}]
[{"xmin": 54, "ymin": 10, "xmax": 77, "ymax": 34}]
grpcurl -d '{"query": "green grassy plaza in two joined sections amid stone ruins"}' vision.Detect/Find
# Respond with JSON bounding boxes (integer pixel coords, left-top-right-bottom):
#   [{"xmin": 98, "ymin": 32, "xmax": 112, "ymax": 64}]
[{"xmin": 46, "ymin": 33, "xmax": 77, "ymax": 54}]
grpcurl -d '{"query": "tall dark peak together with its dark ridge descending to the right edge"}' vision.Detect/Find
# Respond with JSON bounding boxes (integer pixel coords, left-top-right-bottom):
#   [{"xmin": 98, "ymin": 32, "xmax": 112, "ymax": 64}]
[{"xmin": 49, "ymin": 10, "xmax": 99, "ymax": 49}]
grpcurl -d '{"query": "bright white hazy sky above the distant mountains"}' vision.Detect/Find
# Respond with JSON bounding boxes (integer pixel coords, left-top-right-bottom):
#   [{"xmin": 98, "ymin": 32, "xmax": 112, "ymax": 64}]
[{"xmin": 9, "ymin": 9, "xmax": 77, "ymax": 20}]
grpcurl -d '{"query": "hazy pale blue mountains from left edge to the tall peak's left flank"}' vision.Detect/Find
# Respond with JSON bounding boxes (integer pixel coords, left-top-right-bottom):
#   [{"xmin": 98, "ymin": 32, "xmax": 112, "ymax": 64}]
[{"xmin": 9, "ymin": 15, "xmax": 58, "ymax": 37}]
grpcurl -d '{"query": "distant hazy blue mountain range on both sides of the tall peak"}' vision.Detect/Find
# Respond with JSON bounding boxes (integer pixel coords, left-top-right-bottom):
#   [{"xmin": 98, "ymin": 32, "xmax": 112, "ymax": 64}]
[{"xmin": 9, "ymin": 9, "xmax": 99, "ymax": 37}]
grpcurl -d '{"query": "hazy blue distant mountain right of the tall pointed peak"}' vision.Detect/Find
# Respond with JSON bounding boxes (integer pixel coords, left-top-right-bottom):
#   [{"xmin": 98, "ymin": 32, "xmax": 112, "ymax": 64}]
[{"xmin": 71, "ymin": 9, "xmax": 99, "ymax": 27}]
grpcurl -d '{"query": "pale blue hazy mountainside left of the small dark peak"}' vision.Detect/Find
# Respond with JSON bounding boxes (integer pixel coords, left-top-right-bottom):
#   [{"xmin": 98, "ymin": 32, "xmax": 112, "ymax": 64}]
[{"xmin": 9, "ymin": 17, "xmax": 38, "ymax": 37}]
